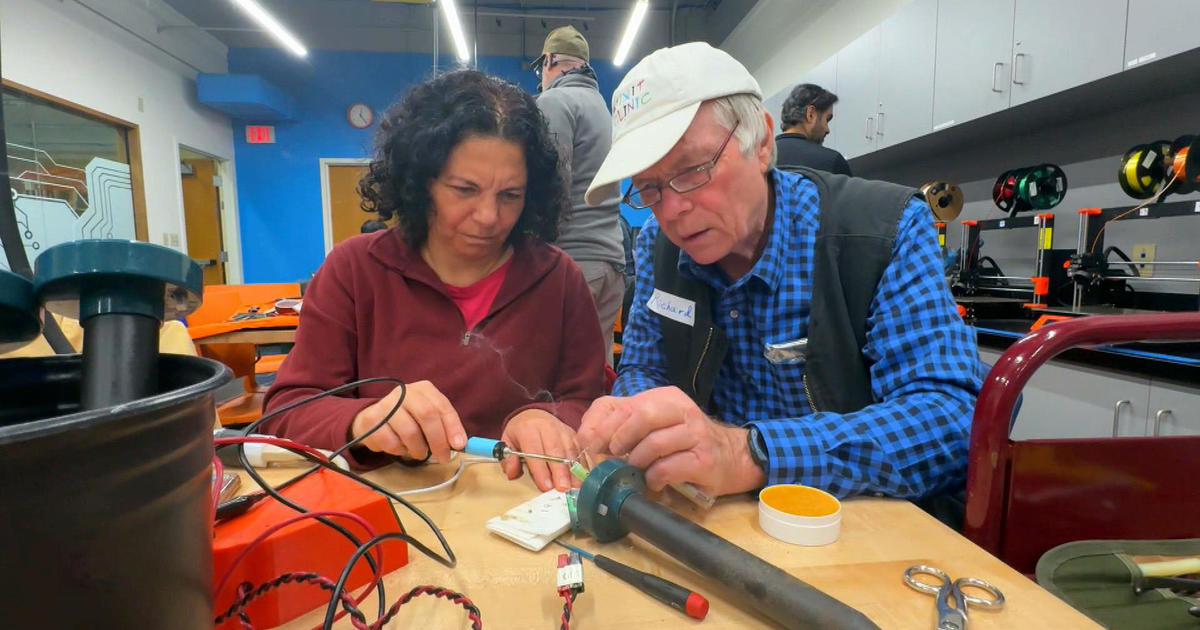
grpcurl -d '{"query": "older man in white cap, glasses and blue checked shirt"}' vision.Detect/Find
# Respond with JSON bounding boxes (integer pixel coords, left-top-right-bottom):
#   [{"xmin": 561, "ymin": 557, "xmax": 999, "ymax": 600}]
[{"xmin": 578, "ymin": 43, "xmax": 980, "ymax": 506}]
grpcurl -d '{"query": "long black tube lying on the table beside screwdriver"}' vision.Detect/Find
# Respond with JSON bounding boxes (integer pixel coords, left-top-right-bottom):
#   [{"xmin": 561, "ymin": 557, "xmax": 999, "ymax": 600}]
[{"xmin": 617, "ymin": 492, "xmax": 878, "ymax": 630}]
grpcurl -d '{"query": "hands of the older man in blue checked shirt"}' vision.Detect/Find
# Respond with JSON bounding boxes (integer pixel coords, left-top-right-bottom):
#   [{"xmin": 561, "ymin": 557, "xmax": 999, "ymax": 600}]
[{"xmin": 580, "ymin": 388, "xmax": 767, "ymax": 494}]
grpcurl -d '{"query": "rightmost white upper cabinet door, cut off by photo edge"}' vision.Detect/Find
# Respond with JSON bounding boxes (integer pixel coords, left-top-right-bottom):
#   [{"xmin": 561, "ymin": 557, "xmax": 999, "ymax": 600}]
[{"xmin": 1124, "ymin": 0, "xmax": 1200, "ymax": 68}]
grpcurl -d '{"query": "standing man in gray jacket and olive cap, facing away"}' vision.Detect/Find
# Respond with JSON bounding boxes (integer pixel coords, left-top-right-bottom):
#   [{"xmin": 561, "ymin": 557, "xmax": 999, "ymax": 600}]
[{"xmin": 530, "ymin": 26, "xmax": 625, "ymax": 366}]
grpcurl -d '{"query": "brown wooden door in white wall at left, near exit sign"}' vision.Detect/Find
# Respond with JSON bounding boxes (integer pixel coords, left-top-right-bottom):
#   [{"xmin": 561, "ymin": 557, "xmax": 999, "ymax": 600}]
[{"xmin": 180, "ymin": 160, "xmax": 226, "ymax": 284}]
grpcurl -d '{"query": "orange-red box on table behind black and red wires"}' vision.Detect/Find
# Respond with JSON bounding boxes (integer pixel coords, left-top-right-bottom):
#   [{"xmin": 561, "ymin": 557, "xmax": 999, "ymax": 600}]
[{"xmin": 212, "ymin": 470, "xmax": 408, "ymax": 630}]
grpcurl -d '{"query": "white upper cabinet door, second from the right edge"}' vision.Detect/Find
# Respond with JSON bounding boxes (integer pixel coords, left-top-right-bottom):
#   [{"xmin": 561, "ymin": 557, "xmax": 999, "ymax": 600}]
[{"xmin": 1010, "ymin": 0, "xmax": 1128, "ymax": 106}]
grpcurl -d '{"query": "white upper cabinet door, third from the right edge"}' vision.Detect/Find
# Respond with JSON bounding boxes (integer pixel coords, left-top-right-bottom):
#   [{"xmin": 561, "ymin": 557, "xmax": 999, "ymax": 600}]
[{"xmin": 913, "ymin": 0, "xmax": 1015, "ymax": 131}]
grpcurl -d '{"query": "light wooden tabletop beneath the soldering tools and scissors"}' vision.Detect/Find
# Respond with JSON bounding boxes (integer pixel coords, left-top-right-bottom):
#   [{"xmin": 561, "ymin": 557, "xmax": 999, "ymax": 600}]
[{"xmin": 253, "ymin": 463, "xmax": 1099, "ymax": 630}]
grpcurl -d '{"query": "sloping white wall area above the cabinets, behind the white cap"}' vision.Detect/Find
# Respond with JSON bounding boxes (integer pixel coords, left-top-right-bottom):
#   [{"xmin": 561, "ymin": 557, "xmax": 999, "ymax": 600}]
[{"xmin": 721, "ymin": 0, "xmax": 907, "ymax": 96}]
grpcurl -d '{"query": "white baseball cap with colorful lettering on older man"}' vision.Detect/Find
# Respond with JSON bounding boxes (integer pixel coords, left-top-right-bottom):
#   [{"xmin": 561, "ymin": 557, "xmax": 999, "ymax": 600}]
[{"xmin": 583, "ymin": 42, "xmax": 762, "ymax": 205}]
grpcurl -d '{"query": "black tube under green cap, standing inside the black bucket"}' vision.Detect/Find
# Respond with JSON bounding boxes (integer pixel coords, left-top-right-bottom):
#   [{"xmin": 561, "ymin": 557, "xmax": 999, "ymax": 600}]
[{"xmin": 82, "ymin": 313, "xmax": 158, "ymax": 409}]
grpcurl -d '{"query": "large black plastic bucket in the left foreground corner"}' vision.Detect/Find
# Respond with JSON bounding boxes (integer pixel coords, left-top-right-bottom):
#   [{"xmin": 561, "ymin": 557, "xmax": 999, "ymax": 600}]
[{"xmin": 0, "ymin": 354, "xmax": 232, "ymax": 630}]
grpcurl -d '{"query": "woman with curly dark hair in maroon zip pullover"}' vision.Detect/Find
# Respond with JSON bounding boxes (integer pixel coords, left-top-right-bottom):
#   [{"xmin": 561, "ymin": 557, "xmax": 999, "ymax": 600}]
[{"xmin": 264, "ymin": 71, "xmax": 605, "ymax": 490}]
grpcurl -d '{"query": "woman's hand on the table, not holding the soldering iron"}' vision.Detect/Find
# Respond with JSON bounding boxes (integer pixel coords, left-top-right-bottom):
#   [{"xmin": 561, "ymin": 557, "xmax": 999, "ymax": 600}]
[{"xmin": 500, "ymin": 409, "xmax": 580, "ymax": 492}]
